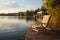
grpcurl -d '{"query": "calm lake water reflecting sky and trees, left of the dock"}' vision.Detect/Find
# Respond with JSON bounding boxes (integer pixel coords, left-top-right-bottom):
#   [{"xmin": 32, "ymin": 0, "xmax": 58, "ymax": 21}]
[{"xmin": 0, "ymin": 16, "xmax": 35, "ymax": 40}]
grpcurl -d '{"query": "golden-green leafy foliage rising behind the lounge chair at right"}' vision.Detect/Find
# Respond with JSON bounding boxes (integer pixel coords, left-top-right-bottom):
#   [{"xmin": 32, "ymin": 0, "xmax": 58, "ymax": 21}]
[{"xmin": 43, "ymin": 0, "xmax": 60, "ymax": 28}]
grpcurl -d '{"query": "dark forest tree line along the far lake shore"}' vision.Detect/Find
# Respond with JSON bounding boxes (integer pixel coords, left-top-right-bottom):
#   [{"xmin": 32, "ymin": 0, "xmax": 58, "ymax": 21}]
[{"xmin": 0, "ymin": 8, "xmax": 40, "ymax": 17}]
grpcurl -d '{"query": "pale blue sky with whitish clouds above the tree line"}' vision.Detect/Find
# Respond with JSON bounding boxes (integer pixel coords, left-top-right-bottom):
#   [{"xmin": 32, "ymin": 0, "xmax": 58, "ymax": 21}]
[{"xmin": 0, "ymin": 0, "xmax": 42, "ymax": 13}]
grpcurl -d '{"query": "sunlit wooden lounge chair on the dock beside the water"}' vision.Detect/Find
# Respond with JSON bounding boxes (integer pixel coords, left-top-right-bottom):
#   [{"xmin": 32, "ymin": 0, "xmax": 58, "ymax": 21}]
[{"xmin": 32, "ymin": 15, "xmax": 50, "ymax": 32}]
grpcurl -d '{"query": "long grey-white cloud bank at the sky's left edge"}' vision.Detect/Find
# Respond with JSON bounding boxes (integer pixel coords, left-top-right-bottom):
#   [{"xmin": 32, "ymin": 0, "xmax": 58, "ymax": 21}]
[{"xmin": 0, "ymin": 2, "xmax": 19, "ymax": 9}]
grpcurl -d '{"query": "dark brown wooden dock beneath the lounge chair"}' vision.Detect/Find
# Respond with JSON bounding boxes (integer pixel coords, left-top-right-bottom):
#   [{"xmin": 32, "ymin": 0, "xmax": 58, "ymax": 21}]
[{"xmin": 25, "ymin": 28, "xmax": 60, "ymax": 40}]
